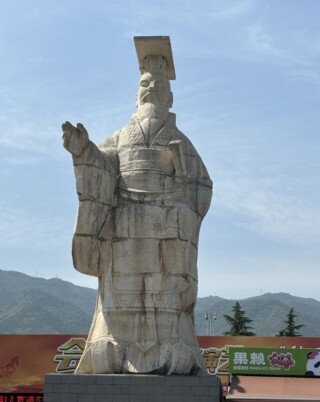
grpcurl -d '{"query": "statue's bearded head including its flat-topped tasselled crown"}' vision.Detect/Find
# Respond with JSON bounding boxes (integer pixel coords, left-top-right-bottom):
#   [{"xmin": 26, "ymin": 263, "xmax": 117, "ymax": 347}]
[{"xmin": 134, "ymin": 36, "xmax": 175, "ymax": 119}]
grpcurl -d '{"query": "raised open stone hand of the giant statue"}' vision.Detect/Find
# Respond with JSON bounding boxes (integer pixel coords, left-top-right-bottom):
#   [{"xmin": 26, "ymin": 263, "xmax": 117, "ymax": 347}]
[{"xmin": 62, "ymin": 121, "xmax": 89, "ymax": 156}]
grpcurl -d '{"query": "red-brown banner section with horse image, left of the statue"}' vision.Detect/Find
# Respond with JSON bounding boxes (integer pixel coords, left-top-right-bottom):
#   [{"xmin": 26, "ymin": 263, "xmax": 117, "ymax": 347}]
[{"xmin": 0, "ymin": 335, "xmax": 86, "ymax": 402}]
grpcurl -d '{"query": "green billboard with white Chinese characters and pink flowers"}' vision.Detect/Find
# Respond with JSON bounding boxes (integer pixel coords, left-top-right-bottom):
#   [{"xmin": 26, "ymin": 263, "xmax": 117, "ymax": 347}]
[{"xmin": 229, "ymin": 347, "xmax": 320, "ymax": 377}]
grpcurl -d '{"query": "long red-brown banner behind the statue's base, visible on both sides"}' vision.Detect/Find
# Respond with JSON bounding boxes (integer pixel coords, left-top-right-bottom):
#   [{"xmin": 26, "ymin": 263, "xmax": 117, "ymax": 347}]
[{"xmin": 0, "ymin": 334, "xmax": 320, "ymax": 402}]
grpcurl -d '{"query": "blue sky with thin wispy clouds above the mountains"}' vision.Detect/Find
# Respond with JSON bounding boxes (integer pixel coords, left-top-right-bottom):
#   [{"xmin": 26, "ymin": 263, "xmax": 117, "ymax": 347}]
[{"xmin": 0, "ymin": 0, "xmax": 320, "ymax": 300}]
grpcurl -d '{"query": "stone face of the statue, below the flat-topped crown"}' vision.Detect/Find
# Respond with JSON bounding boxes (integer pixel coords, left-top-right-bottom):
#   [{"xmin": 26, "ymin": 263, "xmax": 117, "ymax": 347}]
[{"xmin": 137, "ymin": 72, "xmax": 172, "ymax": 109}]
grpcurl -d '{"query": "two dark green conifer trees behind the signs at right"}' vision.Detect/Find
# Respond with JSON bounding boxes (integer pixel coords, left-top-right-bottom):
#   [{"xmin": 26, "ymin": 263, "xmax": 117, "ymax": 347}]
[{"xmin": 223, "ymin": 301, "xmax": 304, "ymax": 336}]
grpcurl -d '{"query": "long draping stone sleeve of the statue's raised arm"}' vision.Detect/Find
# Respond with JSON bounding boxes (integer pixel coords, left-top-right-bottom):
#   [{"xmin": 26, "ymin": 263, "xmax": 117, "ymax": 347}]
[{"xmin": 72, "ymin": 141, "xmax": 118, "ymax": 276}]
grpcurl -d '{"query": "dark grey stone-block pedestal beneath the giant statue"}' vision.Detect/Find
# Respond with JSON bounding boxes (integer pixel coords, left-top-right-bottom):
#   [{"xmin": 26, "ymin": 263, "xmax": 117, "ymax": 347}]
[{"xmin": 44, "ymin": 374, "xmax": 222, "ymax": 402}]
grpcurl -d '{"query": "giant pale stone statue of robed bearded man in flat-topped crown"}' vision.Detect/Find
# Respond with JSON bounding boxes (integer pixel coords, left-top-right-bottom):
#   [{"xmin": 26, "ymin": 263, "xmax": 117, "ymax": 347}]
[{"xmin": 62, "ymin": 37, "xmax": 212, "ymax": 375}]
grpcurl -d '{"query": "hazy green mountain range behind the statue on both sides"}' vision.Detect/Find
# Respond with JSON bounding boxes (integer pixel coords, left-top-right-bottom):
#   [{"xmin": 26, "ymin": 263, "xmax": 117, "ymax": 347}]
[{"xmin": 0, "ymin": 270, "xmax": 320, "ymax": 337}]
